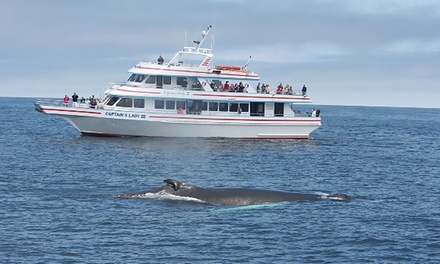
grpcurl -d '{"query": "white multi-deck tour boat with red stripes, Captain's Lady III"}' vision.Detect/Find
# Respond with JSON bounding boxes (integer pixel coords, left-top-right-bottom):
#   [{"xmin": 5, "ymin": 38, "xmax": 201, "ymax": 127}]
[{"xmin": 35, "ymin": 26, "xmax": 321, "ymax": 139}]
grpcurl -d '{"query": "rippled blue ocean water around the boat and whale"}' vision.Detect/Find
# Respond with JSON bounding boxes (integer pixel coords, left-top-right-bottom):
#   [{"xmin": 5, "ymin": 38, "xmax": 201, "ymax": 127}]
[{"xmin": 0, "ymin": 98, "xmax": 440, "ymax": 263}]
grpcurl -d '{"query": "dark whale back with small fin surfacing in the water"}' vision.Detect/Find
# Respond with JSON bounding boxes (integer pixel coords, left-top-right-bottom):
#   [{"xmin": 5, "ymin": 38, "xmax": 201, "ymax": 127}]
[{"xmin": 115, "ymin": 179, "xmax": 351, "ymax": 206}]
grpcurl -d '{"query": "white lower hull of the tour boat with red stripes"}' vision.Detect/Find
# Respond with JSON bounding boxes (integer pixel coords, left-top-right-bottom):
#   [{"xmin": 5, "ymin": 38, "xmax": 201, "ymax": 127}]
[{"xmin": 38, "ymin": 105, "xmax": 321, "ymax": 139}]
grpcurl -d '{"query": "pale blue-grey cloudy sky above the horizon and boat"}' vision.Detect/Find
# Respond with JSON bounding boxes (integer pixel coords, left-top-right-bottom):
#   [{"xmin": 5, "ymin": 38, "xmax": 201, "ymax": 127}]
[{"xmin": 0, "ymin": 0, "xmax": 440, "ymax": 108}]
